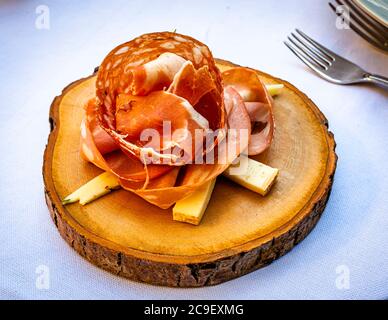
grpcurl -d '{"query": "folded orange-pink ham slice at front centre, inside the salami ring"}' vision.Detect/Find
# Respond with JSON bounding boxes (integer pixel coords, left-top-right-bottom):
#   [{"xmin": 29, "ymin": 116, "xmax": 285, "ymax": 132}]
[{"xmin": 107, "ymin": 91, "xmax": 209, "ymax": 165}]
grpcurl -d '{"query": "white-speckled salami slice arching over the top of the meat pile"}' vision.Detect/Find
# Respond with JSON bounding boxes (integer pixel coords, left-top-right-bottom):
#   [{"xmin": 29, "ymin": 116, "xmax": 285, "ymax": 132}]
[{"xmin": 96, "ymin": 32, "xmax": 224, "ymax": 128}]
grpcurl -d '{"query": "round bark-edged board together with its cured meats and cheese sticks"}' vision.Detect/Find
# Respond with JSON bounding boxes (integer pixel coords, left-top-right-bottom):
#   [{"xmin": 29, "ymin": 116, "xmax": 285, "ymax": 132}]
[{"xmin": 43, "ymin": 32, "xmax": 337, "ymax": 287}]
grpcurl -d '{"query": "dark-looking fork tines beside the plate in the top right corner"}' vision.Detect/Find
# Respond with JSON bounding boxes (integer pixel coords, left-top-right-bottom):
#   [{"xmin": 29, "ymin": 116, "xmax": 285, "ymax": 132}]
[{"xmin": 329, "ymin": 0, "xmax": 388, "ymax": 51}]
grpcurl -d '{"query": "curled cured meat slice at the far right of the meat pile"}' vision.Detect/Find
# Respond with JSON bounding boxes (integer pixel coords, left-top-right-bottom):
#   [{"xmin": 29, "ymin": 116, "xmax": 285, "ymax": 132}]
[{"xmin": 222, "ymin": 67, "xmax": 274, "ymax": 155}]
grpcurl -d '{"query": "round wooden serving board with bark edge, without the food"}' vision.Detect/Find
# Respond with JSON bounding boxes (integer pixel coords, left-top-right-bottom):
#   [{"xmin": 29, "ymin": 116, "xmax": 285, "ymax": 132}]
[{"xmin": 43, "ymin": 60, "xmax": 337, "ymax": 287}]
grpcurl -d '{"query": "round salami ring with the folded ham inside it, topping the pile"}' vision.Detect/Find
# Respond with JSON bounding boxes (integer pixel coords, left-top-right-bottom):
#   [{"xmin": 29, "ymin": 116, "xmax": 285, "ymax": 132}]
[{"xmin": 96, "ymin": 32, "xmax": 225, "ymax": 165}]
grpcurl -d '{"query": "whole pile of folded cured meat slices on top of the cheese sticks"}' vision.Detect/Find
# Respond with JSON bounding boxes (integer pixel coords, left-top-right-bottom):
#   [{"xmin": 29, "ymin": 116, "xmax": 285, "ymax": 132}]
[{"xmin": 81, "ymin": 32, "xmax": 273, "ymax": 208}]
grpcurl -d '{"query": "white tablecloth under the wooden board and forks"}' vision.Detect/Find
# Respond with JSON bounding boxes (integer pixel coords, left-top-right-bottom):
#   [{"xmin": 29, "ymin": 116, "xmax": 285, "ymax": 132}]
[{"xmin": 0, "ymin": 0, "xmax": 388, "ymax": 299}]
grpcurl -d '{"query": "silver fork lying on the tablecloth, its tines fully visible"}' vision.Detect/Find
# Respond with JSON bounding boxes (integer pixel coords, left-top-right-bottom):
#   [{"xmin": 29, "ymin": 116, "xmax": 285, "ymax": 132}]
[{"xmin": 284, "ymin": 29, "xmax": 388, "ymax": 87}]
